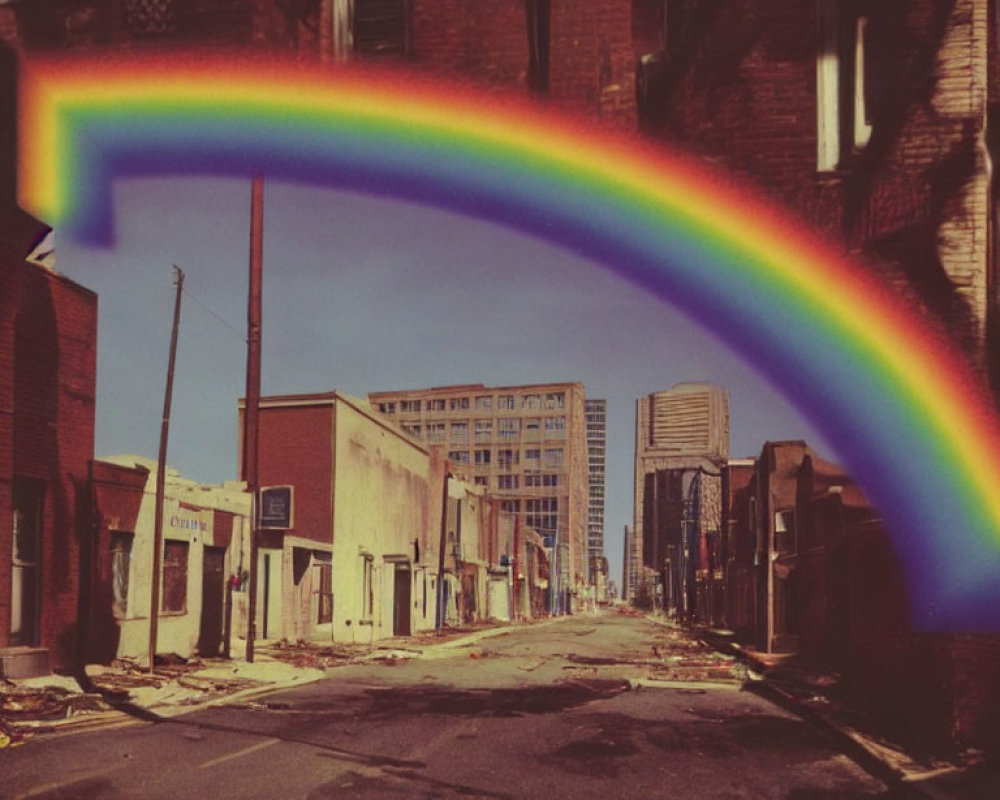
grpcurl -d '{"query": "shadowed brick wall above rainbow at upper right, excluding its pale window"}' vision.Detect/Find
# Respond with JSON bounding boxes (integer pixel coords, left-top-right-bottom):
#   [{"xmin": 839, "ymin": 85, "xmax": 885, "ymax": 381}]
[{"xmin": 654, "ymin": 0, "xmax": 987, "ymax": 363}]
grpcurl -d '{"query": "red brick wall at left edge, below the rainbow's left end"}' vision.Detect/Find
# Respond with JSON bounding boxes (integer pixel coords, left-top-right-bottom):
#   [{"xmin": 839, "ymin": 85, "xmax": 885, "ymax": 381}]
[{"xmin": 0, "ymin": 263, "xmax": 97, "ymax": 668}]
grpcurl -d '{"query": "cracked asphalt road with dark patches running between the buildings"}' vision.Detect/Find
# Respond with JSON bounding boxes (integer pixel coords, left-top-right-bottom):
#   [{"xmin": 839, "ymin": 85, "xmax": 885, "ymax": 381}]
[{"xmin": 0, "ymin": 615, "xmax": 890, "ymax": 800}]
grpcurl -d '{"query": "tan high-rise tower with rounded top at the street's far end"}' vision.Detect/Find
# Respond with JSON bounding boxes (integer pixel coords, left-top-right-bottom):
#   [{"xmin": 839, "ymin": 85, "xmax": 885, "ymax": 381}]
[{"xmin": 622, "ymin": 383, "xmax": 729, "ymax": 600}]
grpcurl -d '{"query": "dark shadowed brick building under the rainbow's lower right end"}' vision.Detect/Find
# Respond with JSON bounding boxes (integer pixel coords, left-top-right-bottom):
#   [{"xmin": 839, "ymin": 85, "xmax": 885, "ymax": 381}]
[{"xmin": 724, "ymin": 441, "xmax": 1000, "ymax": 753}]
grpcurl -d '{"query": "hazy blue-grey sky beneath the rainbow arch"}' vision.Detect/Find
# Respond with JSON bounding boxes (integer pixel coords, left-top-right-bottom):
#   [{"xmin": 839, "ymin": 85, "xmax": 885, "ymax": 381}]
[{"xmin": 57, "ymin": 178, "xmax": 831, "ymax": 580}]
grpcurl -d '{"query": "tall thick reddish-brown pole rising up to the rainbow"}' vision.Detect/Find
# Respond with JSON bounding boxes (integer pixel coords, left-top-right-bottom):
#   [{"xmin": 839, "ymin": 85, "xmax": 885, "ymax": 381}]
[{"xmin": 243, "ymin": 175, "xmax": 264, "ymax": 663}]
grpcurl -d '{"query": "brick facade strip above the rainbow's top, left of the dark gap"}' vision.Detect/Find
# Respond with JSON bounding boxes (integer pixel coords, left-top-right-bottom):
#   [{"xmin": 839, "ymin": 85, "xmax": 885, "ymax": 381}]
[{"xmin": 0, "ymin": 0, "xmax": 637, "ymax": 130}]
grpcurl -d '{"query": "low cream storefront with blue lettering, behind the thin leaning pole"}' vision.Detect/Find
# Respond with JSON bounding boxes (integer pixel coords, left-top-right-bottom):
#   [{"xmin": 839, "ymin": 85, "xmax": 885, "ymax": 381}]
[{"xmin": 86, "ymin": 455, "xmax": 250, "ymax": 663}]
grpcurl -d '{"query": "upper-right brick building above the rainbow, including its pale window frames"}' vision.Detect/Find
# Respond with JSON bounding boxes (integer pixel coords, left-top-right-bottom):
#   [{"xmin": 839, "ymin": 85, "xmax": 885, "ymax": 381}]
[{"xmin": 635, "ymin": 0, "xmax": 1000, "ymax": 384}]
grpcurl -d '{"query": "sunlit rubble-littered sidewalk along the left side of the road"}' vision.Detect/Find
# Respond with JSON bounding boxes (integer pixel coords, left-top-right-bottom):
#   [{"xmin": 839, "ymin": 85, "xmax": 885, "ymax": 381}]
[{"xmin": 0, "ymin": 618, "xmax": 540, "ymax": 750}]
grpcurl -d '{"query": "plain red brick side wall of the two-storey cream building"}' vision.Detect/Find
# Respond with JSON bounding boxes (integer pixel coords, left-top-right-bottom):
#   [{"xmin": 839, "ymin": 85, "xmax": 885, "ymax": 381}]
[{"xmin": 259, "ymin": 406, "xmax": 333, "ymax": 544}]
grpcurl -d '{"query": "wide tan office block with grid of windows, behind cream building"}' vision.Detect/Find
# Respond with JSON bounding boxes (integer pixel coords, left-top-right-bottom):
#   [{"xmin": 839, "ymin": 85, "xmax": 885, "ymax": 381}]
[{"xmin": 368, "ymin": 383, "xmax": 589, "ymax": 599}]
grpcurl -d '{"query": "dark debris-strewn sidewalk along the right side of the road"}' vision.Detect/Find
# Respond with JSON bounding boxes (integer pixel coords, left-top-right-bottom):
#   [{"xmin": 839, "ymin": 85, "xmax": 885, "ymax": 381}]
[{"xmin": 688, "ymin": 618, "xmax": 1000, "ymax": 800}]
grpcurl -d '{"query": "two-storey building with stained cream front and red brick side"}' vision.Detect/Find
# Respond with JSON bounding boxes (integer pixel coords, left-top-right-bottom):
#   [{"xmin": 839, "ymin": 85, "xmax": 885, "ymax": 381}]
[{"xmin": 241, "ymin": 392, "xmax": 444, "ymax": 642}]
